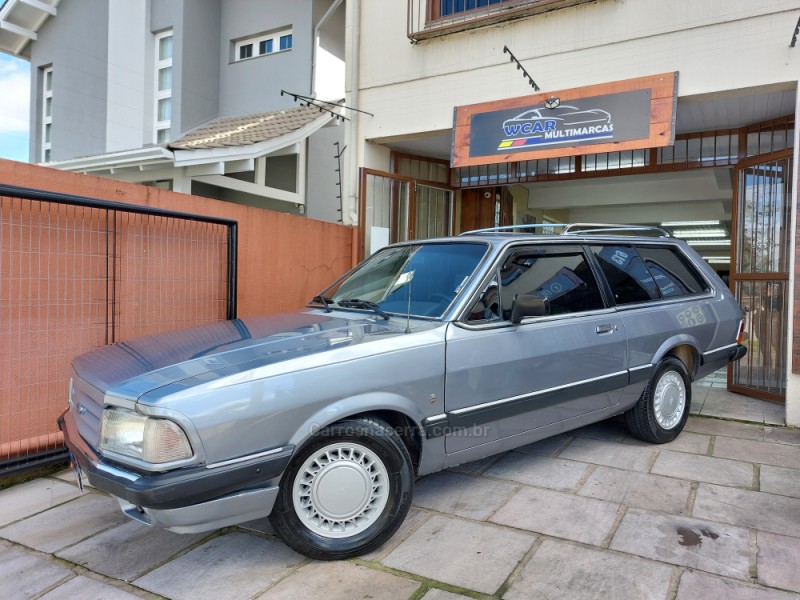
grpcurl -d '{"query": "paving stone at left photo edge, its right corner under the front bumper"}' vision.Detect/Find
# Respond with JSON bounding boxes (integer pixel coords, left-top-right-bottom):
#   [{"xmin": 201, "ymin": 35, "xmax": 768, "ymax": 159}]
[{"xmin": 0, "ymin": 493, "xmax": 128, "ymax": 552}]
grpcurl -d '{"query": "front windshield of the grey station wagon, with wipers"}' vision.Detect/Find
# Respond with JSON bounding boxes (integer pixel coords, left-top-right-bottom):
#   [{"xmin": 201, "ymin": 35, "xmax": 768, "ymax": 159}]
[{"xmin": 315, "ymin": 242, "xmax": 487, "ymax": 318}]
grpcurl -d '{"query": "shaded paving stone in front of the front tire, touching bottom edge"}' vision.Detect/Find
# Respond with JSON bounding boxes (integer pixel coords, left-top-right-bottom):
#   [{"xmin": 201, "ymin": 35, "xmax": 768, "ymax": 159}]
[{"xmin": 134, "ymin": 532, "xmax": 304, "ymax": 600}]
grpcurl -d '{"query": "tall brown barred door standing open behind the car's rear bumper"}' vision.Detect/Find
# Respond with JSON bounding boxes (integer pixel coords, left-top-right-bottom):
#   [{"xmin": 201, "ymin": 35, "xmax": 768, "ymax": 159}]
[{"xmin": 728, "ymin": 152, "xmax": 792, "ymax": 402}]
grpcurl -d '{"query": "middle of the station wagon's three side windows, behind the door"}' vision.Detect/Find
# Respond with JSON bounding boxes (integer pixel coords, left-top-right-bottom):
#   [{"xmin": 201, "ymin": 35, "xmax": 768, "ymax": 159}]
[{"xmin": 592, "ymin": 245, "xmax": 661, "ymax": 304}]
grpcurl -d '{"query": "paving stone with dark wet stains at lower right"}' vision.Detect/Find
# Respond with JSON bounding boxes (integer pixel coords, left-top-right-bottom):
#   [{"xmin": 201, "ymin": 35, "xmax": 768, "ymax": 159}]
[{"xmin": 610, "ymin": 508, "xmax": 750, "ymax": 579}]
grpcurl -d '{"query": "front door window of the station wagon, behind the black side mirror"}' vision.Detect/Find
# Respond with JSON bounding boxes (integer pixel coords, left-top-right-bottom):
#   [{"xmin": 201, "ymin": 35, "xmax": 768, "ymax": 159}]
[{"xmin": 500, "ymin": 248, "xmax": 604, "ymax": 319}]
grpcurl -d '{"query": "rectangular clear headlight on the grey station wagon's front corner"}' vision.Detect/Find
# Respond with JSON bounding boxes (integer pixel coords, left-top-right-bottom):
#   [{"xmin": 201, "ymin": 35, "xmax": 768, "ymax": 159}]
[{"xmin": 100, "ymin": 408, "xmax": 192, "ymax": 464}]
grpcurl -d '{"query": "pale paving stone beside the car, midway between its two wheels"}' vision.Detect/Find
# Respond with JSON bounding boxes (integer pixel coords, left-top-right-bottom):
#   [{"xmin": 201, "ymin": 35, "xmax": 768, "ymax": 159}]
[{"xmin": 484, "ymin": 452, "xmax": 589, "ymax": 490}]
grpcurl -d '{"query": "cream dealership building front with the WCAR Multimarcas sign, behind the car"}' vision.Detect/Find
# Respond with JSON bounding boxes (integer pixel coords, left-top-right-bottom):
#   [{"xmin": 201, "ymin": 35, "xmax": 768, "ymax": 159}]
[{"xmin": 345, "ymin": 0, "xmax": 800, "ymax": 425}]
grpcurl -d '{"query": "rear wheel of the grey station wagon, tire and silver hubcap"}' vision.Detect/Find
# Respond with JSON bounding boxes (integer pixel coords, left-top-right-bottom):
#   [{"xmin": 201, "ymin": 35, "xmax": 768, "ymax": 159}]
[{"xmin": 625, "ymin": 356, "xmax": 692, "ymax": 444}]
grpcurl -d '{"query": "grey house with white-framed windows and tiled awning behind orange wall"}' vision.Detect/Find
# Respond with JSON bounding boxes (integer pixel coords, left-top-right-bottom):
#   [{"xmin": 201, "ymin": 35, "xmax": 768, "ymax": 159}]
[{"xmin": 0, "ymin": 0, "xmax": 345, "ymax": 221}]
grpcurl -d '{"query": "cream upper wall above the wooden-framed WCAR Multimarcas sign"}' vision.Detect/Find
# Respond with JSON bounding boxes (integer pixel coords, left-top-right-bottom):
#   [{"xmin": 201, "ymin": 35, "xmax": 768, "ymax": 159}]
[{"xmin": 359, "ymin": 0, "xmax": 800, "ymax": 146}]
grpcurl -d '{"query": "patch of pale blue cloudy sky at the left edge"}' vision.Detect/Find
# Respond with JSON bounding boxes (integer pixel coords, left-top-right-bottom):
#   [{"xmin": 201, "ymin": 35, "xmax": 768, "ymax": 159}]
[{"xmin": 0, "ymin": 53, "xmax": 30, "ymax": 162}]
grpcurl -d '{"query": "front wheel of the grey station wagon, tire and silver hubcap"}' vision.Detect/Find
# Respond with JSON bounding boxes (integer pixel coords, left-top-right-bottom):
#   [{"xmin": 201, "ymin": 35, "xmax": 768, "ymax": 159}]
[{"xmin": 270, "ymin": 417, "xmax": 414, "ymax": 560}]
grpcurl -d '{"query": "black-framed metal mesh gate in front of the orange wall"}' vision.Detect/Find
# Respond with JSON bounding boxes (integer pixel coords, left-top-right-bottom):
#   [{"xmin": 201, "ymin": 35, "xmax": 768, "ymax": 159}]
[{"xmin": 0, "ymin": 185, "xmax": 237, "ymax": 476}]
